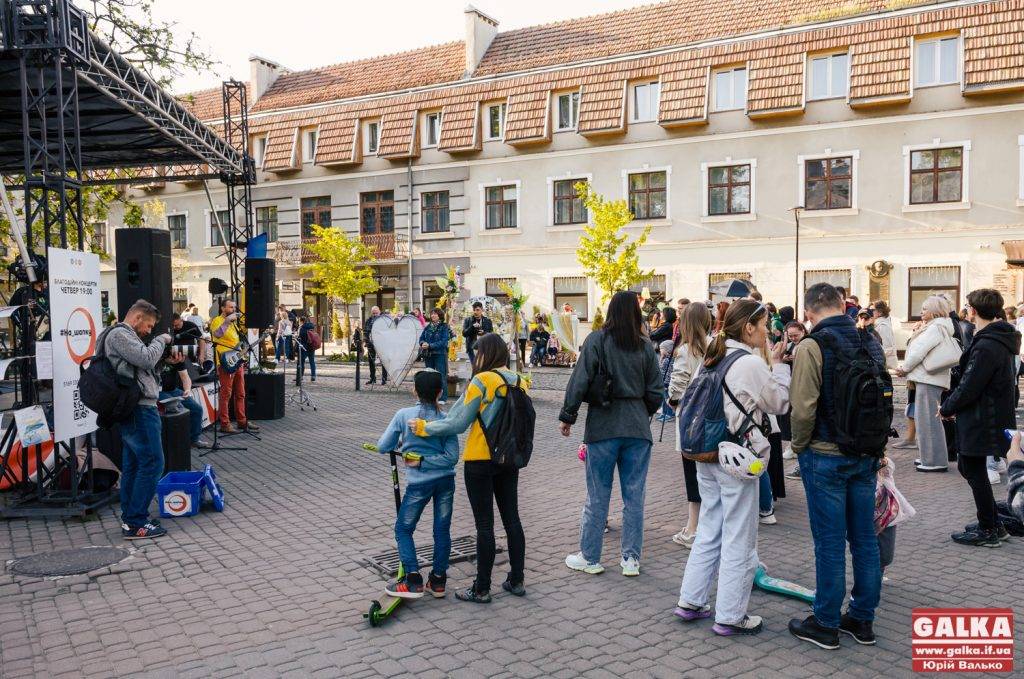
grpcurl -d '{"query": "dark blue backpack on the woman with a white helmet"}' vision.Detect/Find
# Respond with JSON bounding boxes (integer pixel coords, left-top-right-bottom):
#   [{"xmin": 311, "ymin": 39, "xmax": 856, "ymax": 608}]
[{"xmin": 679, "ymin": 351, "xmax": 765, "ymax": 462}]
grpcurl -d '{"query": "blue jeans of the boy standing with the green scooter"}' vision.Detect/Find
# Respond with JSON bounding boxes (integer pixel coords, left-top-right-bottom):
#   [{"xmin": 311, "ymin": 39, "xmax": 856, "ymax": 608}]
[{"xmin": 394, "ymin": 474, "xmax": 455, "ymax": 576}]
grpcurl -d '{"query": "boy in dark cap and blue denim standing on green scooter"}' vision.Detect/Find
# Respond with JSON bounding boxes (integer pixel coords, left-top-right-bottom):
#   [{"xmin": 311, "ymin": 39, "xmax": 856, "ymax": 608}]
[{"xmin": 377, "ymin": 370, "xmax": 459, "ymax": 599}]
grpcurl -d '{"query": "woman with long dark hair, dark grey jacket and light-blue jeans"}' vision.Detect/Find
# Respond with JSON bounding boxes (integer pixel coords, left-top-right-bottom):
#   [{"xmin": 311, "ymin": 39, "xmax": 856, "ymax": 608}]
[{"xmin": 558, "ymin": 292, "xmax": 665, "ymax": 576}]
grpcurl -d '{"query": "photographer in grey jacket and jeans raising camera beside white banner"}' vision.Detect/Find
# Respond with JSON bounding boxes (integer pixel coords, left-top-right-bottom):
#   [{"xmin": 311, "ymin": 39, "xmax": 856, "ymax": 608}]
[{"xmin": 97, "ymin": 299, "xmax": 174, "ymax": 540}]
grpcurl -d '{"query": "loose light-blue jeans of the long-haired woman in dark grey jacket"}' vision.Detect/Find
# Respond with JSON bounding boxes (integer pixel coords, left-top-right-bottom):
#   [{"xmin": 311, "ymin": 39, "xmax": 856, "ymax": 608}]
[{"xmin": 580, "ymin": 438, "xmax": 651, "ymax": 563}]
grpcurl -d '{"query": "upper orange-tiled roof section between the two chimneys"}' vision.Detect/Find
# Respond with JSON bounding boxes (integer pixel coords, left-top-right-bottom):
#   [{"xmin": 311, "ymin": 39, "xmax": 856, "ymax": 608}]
[{"xmin": 252, "ymin": 42, "xmax": 466, "ymax": 113}]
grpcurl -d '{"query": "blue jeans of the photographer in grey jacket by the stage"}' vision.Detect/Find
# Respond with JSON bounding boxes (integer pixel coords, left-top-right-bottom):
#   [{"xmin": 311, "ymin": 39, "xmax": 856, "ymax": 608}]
[{"xmin": 121, "ymin": 406, "xmax": 164, "ymax": 528}]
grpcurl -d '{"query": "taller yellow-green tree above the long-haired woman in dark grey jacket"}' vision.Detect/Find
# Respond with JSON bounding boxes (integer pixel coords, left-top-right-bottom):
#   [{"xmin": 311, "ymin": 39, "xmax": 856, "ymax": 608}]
[{"xmin": 575, "ymin": 181, "xmax": 654, "ymax": 304}]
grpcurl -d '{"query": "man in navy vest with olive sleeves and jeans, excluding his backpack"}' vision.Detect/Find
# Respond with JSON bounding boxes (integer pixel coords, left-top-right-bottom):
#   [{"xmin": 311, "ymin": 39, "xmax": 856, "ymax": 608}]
[{"xmin": 790, "ymin": 283, "xmax": 886, "ymax": 649}]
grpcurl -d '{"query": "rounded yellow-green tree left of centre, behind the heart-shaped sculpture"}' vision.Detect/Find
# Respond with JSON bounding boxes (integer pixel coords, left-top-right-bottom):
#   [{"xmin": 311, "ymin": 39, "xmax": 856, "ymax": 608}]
[{"xmin": 299, "ymin": 224, "xmax": 380, "ymax": 348}]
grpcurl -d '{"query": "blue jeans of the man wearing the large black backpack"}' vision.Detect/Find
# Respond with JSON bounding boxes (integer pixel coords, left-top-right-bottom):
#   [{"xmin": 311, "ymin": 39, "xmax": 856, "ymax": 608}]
[{"xmin": 800, "ymin": 449, "xmax": 882, "ymax": 629}]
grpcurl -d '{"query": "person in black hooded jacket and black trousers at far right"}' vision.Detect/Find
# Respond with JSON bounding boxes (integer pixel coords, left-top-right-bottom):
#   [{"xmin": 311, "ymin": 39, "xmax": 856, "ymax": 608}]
[{"xmin": 939, "ymin": 288, "xmax": 1021, "ymax": 547}]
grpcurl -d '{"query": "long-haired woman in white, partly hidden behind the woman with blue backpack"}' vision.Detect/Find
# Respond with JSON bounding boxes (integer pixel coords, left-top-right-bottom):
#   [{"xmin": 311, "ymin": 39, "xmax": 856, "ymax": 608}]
[{"xmin": 669, "ymin": 302, "xmax": 711, "ymax": 549}]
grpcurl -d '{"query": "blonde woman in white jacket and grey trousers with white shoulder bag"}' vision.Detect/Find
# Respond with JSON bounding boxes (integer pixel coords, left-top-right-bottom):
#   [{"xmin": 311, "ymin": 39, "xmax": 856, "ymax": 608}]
[{"xmin": 896, "ymin": 295, "xmax": 963, "ymax": 471}]
